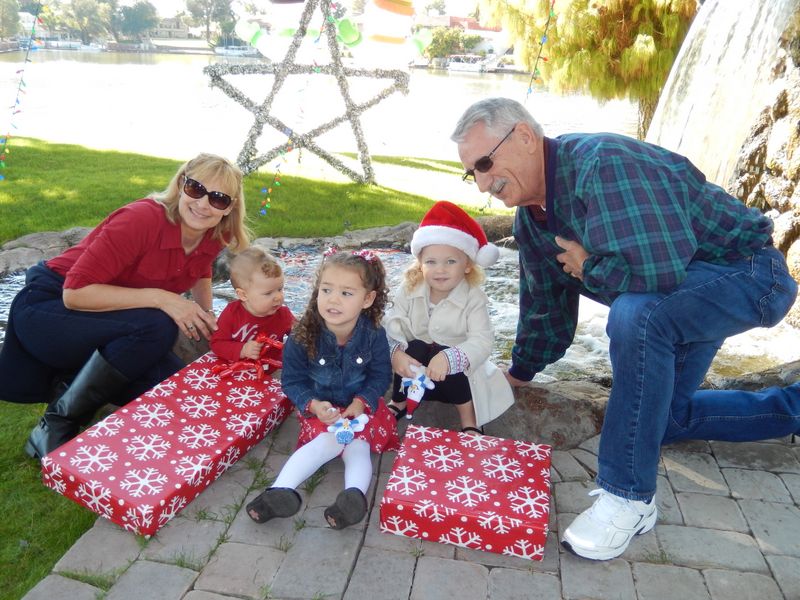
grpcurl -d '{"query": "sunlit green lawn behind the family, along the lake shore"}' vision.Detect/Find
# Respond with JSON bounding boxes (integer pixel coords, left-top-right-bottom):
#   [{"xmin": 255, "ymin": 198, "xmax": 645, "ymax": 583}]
[{"xmin": 0, "ymin": 138, "xmax": 488, "ymax": 244}]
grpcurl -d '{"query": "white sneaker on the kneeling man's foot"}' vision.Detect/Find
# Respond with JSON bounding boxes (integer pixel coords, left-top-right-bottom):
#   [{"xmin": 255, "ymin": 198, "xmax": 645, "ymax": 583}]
[{"xmin": 561, "ymin": 490, "xmax": 658, "ymax": 560}]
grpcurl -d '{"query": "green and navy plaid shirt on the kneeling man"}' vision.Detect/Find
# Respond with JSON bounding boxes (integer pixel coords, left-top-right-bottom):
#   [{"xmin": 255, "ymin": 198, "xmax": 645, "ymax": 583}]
[{"xmin": 510, "ymin": 133, "xmax": 772, "ymax": 381}]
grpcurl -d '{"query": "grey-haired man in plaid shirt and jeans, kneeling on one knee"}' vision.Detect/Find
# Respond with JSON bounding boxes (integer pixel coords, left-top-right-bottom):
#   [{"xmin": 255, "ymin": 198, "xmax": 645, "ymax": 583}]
[{"xmin": 452, "ymin": 98, "xmax": 800, "ymax": 560}]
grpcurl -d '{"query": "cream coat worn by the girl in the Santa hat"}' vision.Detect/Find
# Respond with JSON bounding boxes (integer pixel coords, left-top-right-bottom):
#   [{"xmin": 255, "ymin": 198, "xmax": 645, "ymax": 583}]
[{"xmin": 384, "ymin": 281, "xmax": 514, "ymax": 427}]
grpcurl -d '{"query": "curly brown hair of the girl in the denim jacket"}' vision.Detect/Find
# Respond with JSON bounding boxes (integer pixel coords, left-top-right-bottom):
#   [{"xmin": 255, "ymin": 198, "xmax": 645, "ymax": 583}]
[{"xmin": 292, "ymin": 252, "xmax": 389, "ymax": 358}]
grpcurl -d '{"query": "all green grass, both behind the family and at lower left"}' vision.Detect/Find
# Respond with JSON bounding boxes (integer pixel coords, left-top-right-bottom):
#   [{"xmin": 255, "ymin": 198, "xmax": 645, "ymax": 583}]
[{"xmin": 0, "ymin": 138, "xmax": 506, "ymax": 600}]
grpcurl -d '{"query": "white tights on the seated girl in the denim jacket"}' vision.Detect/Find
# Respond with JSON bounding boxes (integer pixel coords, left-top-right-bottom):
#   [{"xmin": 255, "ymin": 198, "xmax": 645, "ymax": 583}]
[{"xmin": 272, "ymin": 432, "xmax": 372, "ymax": 495}]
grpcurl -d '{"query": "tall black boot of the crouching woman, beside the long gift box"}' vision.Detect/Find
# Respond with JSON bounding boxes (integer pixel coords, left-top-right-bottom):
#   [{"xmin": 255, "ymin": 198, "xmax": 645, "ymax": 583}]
[{"xmin": 25, "ymin": 350, "xmax": 129, "ymax": 459}]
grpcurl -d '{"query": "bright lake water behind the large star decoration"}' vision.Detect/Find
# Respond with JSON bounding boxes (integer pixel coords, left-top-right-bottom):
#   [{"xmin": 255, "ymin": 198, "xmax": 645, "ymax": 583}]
[{"xmin": 0, "ymin": 50, "xmax": 637, "ymax": 163}]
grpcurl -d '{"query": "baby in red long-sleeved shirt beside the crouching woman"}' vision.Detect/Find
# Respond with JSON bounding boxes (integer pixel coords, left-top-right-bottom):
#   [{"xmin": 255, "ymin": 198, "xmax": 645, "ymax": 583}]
[{"xmin": 211, "ymin": 246, "xmax": 294, "ymax": 371}]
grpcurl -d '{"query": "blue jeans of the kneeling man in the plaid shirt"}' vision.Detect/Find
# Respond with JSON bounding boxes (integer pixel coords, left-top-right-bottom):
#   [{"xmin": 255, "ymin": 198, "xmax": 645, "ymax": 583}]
[{"xmin": 597, "ymin": 246, "xmax": 800, "ymax": 502}]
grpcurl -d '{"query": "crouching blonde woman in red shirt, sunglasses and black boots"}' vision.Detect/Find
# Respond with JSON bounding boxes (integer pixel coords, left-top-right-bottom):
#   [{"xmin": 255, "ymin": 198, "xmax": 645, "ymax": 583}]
[{"xmin": 0, "ymin": 154, "xmax": 249, "ymax": 458}]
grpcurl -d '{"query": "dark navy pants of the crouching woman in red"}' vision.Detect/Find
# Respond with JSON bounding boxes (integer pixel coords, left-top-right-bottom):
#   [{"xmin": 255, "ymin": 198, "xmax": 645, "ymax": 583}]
[{"xmin": 0, "ymin": 263, "xmax": 183, "ymax": 402}]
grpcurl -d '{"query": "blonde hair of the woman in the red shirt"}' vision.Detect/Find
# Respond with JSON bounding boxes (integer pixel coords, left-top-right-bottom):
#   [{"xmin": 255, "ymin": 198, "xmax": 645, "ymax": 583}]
[{"xmin": 150, "ymin": 153, "xmax": 250, "ymax": 252}]
